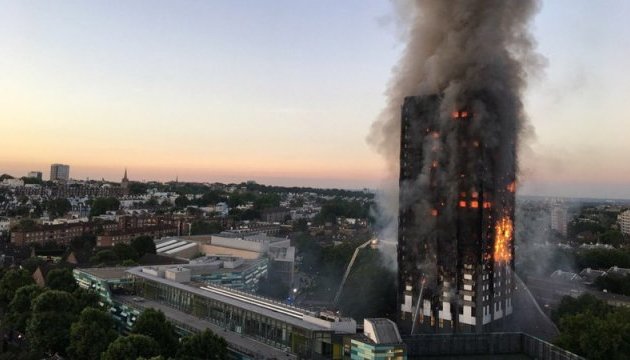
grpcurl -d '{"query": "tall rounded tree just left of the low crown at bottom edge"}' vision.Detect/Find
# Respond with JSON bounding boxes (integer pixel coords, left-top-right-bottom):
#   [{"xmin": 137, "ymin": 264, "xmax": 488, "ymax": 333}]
[{"xmin": 68, "ymin": 307, "xmax": 118, "ymax": 359}]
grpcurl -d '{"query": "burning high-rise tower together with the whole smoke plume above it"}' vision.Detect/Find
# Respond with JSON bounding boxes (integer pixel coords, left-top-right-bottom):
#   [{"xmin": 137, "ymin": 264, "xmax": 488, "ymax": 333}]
[{"xmin": 369, "ymin": 0, "xmax": 541, "ymax": 333}]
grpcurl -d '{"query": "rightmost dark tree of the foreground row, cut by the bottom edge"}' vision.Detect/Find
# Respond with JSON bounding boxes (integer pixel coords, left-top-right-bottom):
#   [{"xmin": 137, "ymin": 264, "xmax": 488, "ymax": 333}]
[{"xmin": 177, "ymin": 329, "xmax": 227, "ymax": 360}]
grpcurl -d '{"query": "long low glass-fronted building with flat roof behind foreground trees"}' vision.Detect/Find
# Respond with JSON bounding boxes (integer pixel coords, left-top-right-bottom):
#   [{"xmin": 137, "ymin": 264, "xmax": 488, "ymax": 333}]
[{"xmin": 74, "ymin": 267, "xmax": 356, "ymax": 359}]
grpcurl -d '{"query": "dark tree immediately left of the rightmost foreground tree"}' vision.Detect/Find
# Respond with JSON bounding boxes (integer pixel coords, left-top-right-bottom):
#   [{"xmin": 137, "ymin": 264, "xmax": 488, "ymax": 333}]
[{"xmin": 131, "ymin": 308, "xmax": 178, "ymax": 356}]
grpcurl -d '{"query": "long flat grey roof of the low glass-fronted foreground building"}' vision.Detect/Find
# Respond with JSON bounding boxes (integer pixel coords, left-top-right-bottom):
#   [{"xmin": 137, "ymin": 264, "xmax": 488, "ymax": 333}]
[{"xmin": 127, "ymin": 267, "xmax": 332, "ymax": 331}]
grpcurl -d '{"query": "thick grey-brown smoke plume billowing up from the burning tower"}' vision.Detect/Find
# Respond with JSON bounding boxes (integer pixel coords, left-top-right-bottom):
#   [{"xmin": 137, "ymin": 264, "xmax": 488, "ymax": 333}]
[{"xmin": 368, "ymin": 0, "xmax": 541, "ymax": 264}]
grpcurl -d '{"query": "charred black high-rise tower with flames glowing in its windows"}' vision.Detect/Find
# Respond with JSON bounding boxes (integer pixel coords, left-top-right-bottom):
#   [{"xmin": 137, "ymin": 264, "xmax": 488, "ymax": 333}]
[{"xmin": 397, "ymin": 94, "xmax": 516, "ymax": 334}]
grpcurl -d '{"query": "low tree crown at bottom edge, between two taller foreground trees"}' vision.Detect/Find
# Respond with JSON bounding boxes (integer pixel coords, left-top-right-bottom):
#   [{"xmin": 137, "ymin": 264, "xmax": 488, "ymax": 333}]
[{"xmin": 101, "ymin": 334, "xmax": 160, "ymax": 360}]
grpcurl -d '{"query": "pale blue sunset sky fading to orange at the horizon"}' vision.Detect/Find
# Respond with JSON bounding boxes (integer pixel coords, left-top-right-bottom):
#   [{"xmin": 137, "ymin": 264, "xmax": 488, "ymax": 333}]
[{"xmin": 0, "ymin": 0, "xmax": 630, "ymax": 197}]
